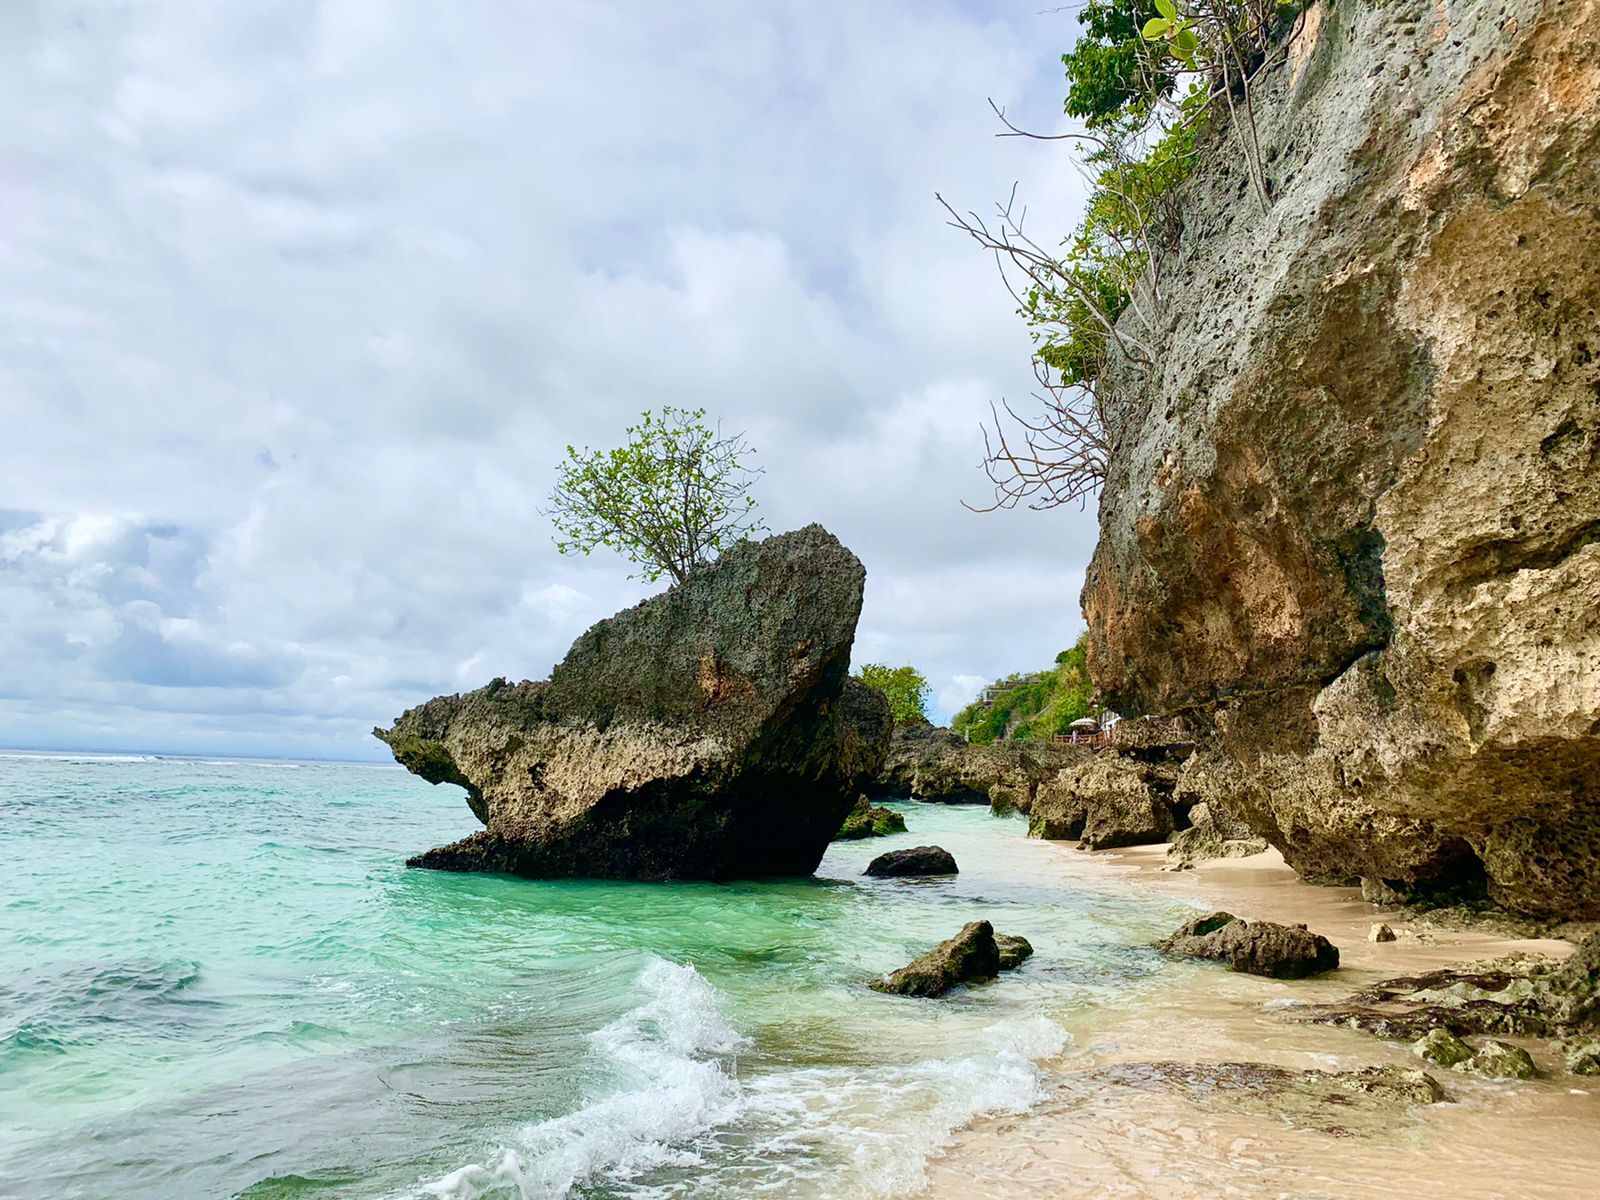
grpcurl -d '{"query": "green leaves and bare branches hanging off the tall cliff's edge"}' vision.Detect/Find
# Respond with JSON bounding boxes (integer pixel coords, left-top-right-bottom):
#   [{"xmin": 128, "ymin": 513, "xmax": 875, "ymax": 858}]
[{"xmin": 941, "ymin": 0, "xmax": 1304, "ymax": 510}]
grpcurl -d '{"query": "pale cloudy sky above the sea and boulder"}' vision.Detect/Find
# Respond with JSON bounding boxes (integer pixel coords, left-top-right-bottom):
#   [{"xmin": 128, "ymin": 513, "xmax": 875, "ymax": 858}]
[{"xmin": 0, "ymin": 0, "xmax": 1094, "ymax": 757}]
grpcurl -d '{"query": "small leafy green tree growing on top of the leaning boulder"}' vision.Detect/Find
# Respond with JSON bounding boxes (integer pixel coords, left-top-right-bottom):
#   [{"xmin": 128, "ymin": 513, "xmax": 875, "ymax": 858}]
[{"xmin": 547, "ymin": 406, "xmax": 765, "ymax": 582}]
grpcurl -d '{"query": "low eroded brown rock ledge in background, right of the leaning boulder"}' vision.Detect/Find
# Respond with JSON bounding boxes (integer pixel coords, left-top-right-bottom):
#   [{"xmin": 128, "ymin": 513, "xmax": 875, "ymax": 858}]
[{"xmin": 867, "ymin": 725, "xmax": 1086, "ymax": 813}]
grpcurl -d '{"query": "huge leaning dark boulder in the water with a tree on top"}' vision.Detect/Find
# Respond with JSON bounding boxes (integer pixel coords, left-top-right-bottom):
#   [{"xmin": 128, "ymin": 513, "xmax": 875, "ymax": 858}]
[{"xmin": 374, "ymin": 525, "xmax": 890, "ymax": 878}]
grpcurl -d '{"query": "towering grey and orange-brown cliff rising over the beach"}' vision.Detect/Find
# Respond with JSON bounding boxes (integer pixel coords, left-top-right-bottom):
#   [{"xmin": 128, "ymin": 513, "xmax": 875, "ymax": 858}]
[{"xmin": 1083, "ymin": 0, "xmax": 1600, "ymax": 918}]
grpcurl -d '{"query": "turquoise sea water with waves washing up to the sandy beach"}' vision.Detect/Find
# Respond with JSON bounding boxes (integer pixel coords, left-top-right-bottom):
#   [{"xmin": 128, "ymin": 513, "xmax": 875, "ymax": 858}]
[{"xmin": 0, "ymin": 754, "xmax": 1182, "ymax": 1200}]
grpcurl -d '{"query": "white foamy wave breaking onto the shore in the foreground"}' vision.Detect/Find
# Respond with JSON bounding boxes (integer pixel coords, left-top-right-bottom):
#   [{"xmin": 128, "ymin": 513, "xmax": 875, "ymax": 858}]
[{"xmin": 422, "ymin": 960, "xmax": 1069, "ymax": 1200}]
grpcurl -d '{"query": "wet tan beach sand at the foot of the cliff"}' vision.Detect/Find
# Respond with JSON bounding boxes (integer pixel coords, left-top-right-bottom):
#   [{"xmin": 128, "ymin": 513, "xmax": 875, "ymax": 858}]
[{"xmin": 925, "ymin": 843, "xmax": 1600, "ymax": 1200}]
